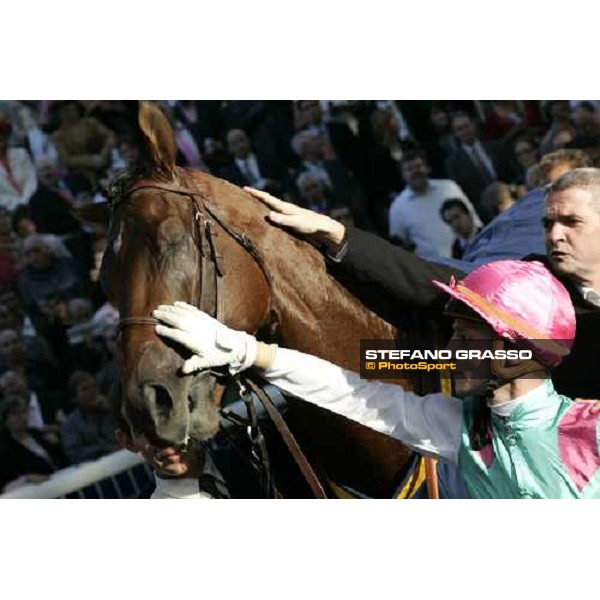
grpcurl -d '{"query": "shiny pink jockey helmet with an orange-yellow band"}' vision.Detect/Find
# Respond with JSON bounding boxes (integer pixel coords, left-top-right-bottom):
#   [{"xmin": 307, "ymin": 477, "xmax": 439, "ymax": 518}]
[{"xmin": 433, "ymin": 260, "xmax": 575, "ymax": 367}]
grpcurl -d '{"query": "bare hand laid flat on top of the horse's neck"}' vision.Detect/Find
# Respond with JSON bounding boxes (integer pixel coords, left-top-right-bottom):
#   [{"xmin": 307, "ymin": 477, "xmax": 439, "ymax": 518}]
[{"xmin": 244, "ymin": 187, "xmax": 346, "ymax": 250}]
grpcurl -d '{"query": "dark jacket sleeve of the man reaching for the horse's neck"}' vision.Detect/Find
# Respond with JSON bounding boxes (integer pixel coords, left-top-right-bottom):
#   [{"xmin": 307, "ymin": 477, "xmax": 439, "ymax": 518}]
[{"xmin": 330, "ymin": 228, "xmax": 464, "ymax": 322}]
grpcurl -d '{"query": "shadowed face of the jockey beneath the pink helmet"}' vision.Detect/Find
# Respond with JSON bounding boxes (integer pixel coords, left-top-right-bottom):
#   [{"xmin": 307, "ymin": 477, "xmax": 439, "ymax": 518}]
[{"xmin": 447, "ymin": 318, "xmax": 493, "ymax": 398}]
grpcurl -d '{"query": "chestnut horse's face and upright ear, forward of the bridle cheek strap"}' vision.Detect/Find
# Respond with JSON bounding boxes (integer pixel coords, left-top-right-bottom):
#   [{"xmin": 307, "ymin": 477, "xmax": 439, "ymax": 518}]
[{"xmin": 89, "ymin": 103, "xmax": 270, "ymax": 445}]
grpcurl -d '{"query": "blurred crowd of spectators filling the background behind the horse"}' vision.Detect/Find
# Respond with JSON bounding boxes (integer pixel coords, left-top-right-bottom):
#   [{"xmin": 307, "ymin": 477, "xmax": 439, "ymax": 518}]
[{"xmin": 0, "ymin": 100, "xmax": 600, "ymax": 491}]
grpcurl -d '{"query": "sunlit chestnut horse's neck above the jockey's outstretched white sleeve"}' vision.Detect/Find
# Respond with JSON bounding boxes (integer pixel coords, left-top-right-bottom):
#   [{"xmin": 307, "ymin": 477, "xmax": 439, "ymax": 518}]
[{"xmin": 190, "ymin": 171, "xmax": 396, "ymax": 370}]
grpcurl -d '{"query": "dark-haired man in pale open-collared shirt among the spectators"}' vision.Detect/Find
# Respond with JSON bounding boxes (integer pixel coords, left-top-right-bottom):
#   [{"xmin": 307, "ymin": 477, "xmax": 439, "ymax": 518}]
[{"xmin": 389, "ymin": 150, "xmax": 481, "ymax": 257}]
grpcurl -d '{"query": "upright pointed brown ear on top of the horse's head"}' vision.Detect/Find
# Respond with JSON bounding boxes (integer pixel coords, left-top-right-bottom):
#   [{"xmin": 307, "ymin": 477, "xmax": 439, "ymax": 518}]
[{"xmin": 138, "ymin": 102, "xmax": 177, "ymax": 177}]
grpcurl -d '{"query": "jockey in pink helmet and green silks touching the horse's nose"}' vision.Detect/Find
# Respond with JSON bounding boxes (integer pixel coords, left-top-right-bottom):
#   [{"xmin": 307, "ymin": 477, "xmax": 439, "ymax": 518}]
[{"xmin": 153, "ymin": 260, "xmax": 600, "ymax": 498}]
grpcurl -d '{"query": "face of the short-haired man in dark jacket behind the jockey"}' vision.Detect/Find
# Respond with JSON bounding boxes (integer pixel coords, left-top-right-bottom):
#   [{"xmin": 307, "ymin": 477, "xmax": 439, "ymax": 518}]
[{"xmin": 543, "ymin": 188, "xmax": 600, "ymax": 284}]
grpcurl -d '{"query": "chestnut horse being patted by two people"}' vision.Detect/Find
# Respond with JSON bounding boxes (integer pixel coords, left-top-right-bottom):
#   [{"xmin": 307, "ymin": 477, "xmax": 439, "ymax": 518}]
[{"xmin": 101, "ymin": 103, "xmax": 418, "ymax": 497}]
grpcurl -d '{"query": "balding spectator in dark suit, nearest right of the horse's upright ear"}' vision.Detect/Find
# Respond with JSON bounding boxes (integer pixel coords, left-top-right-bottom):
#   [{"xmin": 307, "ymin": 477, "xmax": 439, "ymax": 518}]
[{"xmin": 220, "ymin": 129, "xmax": 282, "ymax": 193}]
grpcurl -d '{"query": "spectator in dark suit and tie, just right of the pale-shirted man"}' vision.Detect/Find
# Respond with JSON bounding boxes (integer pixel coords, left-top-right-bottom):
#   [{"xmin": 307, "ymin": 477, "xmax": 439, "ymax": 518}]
[{"xmin": 445, "ymin": 112, "xmax": 515, "ymax": 214}]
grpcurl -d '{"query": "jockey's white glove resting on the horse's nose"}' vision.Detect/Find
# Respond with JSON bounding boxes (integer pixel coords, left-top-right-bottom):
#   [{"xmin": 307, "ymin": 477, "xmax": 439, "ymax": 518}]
[{"xmin": 152, "ymin": 302, "xmax": 257, "ymax": 374}]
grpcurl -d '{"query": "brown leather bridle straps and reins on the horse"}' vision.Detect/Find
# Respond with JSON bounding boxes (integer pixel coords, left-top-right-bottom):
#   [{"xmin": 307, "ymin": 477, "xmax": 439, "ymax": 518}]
[{"xmin": 111, "ymin": 180, "xmax": 327, "ymax": 499}]
